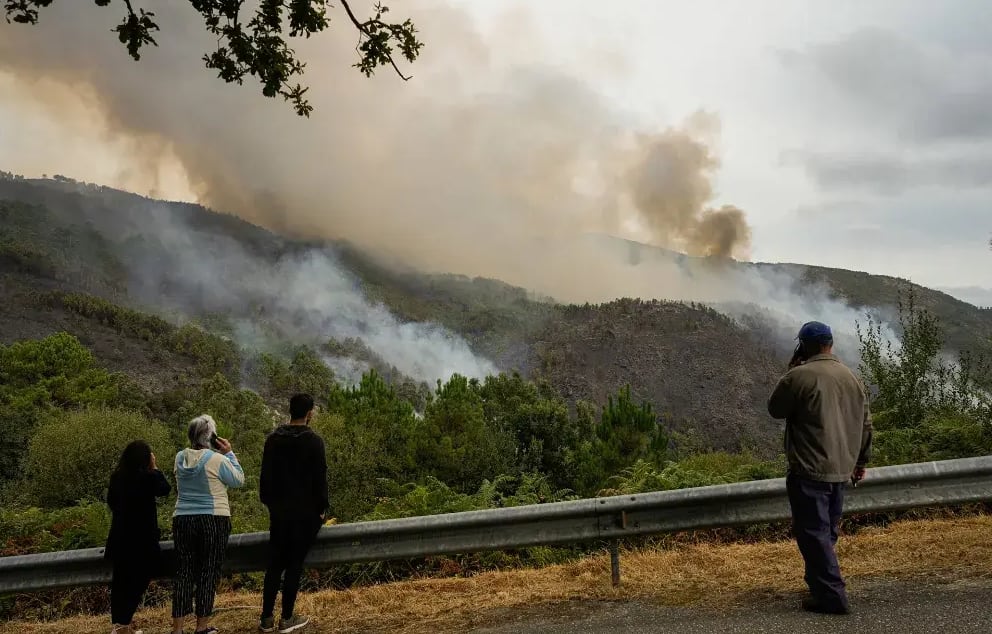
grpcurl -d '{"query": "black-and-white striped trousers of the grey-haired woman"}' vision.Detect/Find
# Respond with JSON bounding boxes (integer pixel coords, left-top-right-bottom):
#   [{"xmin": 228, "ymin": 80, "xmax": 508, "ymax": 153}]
[{"xmin": 172, "ymin": 515, "xmax": 231, "ymax": 619}]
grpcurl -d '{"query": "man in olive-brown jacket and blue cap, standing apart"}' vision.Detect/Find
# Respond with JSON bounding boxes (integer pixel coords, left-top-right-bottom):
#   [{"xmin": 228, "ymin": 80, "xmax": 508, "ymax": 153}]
[{"xmin": 768, "ymin": 321, "xmax": 872, "ymax": 614}]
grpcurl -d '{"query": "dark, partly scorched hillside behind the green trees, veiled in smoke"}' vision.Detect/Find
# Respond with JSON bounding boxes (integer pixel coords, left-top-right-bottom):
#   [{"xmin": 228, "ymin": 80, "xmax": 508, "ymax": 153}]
[{"xmin": 0, "ymin": 175, "xmax": 992, "ymax": 455}]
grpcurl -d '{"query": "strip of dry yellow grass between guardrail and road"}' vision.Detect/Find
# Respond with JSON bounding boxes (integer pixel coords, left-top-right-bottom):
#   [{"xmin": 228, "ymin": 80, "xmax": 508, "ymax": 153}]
[{"xmin": 0, "ymin": 516, "xmax": 992, "ymax": 634}]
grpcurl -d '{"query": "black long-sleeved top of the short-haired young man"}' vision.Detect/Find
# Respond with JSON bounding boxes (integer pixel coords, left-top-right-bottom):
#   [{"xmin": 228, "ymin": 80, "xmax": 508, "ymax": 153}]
[{"xmin": 258, "ymin": 425, "xmax": 330, "ymax": 516}]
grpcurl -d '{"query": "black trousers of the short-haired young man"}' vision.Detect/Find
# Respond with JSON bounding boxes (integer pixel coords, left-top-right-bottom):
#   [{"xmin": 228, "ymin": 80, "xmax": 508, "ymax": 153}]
[{"xmin": 262, "ymin": 512, "xmax": 320, "ymax": 619}]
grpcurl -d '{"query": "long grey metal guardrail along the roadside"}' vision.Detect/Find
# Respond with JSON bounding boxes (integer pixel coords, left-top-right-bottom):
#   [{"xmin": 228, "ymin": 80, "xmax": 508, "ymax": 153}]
[{"xmin": 0, "ymin": 456, "xmax": 992, "ymax": 594}]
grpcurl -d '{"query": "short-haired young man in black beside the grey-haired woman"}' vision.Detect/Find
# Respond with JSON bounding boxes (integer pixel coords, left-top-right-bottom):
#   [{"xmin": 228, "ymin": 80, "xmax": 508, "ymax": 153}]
[{"xmin": 258, "ymin": 394, "xmax": 329, "ymax": 634}]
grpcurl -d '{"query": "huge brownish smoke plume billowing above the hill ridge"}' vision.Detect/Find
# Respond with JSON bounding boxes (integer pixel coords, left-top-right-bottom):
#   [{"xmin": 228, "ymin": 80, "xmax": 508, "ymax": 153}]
[{"xmin": 0, "ymin": 0, "xmax": 892, "ymax": 360}]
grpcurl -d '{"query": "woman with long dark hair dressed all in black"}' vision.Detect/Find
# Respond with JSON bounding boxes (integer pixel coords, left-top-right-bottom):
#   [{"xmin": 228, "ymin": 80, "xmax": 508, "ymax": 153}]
[{"xmin": 104, "ymin": 440, "xmax": 171, "ymax": 634}]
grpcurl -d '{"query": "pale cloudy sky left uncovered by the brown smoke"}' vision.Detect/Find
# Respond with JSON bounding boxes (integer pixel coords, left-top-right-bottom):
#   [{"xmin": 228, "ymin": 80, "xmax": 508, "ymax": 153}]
[{"xmin": 0, "ymin": 0, "xmax": 992, "ymax": 288}]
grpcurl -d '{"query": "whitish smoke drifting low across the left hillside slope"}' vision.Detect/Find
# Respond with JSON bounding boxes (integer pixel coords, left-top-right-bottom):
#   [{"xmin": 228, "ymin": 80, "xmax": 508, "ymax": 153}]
[{"xmin": 123, "ymin": 201, "xmax": 497, "ymax": 383}]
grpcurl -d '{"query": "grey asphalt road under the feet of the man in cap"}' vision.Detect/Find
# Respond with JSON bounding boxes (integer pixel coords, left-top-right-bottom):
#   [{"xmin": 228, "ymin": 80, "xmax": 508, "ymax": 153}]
[{"xmin": 472, "ymin": 579, "xmax": 992, "ymax": 634}]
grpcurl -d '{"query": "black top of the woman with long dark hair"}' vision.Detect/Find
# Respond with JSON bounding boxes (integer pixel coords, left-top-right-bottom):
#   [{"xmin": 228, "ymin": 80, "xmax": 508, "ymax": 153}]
[{"xmin": 104, "ymin": 469, "xmax": 171, "ymax": 559}]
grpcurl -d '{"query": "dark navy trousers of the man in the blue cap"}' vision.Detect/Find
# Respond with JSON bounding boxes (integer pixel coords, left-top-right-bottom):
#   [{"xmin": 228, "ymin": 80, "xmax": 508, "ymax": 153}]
[{"xmin": 786, "ymin": 475, "xmax": 847, "ymax": 607}]
